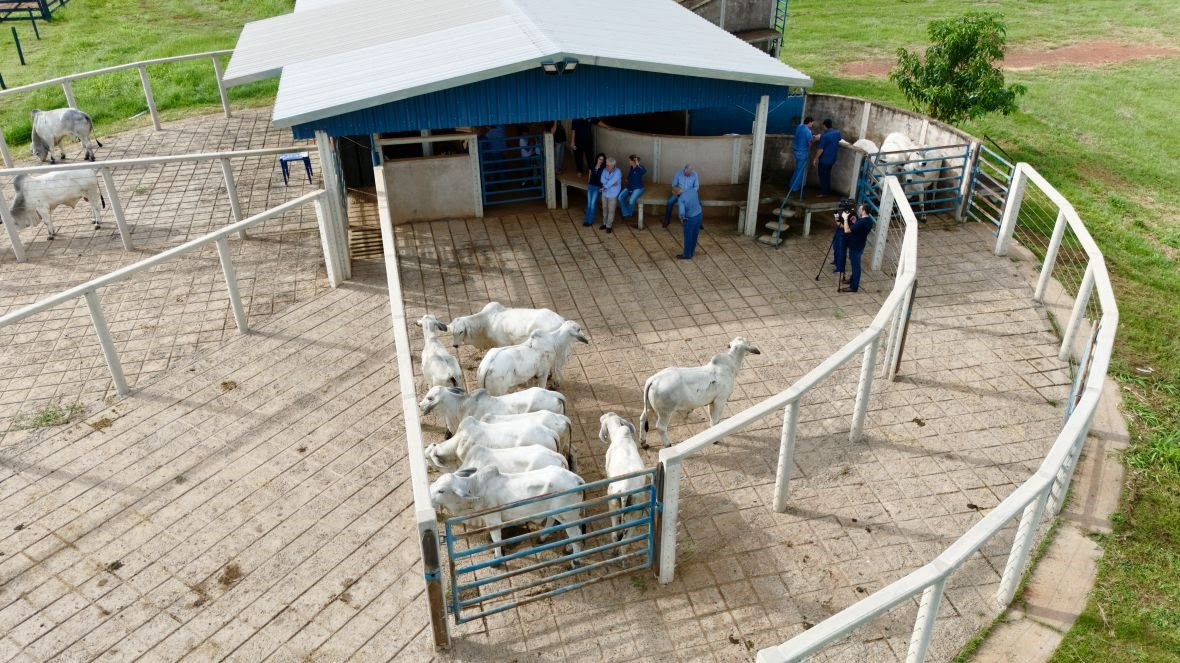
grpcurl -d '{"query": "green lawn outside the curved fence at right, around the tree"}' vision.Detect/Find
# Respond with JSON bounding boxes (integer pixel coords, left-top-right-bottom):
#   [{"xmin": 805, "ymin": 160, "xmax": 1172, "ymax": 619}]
[{"xmin": 782, "ymin": 0, "xmax": 1180, "ymax": 662}]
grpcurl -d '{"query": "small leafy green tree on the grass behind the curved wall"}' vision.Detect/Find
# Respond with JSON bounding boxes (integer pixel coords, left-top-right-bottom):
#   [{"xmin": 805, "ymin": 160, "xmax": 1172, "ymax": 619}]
[{"xmin": 889, "ymin": 12, "xmax": 1028, "ymax": 123}]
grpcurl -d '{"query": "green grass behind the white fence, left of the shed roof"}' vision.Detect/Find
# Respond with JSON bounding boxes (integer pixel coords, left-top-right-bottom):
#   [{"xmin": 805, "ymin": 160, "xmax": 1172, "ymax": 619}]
[{"xmin": 0, "ymin": 0, "xmax": 295, "ymax": 148}]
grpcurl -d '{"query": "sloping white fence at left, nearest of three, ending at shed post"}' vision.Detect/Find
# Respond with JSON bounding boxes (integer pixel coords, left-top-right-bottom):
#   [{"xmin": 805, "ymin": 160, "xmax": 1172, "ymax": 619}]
[{"xmin": 0, "ymin": 190, "xmax": 328, "ymax": 395}]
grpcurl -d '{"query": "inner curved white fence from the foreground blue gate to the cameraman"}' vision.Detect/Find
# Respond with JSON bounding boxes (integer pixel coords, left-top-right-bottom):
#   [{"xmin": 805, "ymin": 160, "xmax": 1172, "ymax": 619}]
[{"xmin": 660, "ymin": 177, "xmax": 918, "ymax": 584}]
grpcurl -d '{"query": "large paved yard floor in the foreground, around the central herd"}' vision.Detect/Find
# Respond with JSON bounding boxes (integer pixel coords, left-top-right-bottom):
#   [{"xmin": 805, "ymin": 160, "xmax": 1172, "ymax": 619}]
[{"xmin": 0, "ymin": 198, "xmax": 1068, "ymax": 661}]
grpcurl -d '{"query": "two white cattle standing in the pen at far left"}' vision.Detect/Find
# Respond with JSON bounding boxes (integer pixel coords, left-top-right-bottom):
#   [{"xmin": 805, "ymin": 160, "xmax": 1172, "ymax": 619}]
[{"xmin": 8, "ymin": 109, "xmax": 106, "ymax": 239}]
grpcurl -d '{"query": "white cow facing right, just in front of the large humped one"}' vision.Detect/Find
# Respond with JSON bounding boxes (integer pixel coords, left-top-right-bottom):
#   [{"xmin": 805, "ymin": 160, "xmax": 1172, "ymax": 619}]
[{"xmin": 477, "ymin": 320, "xmax": 590, "ymax": 396}]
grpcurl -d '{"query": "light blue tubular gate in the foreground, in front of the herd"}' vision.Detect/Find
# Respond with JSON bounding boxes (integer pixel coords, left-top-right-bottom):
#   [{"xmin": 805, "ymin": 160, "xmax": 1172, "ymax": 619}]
[{"xmin": 444, "ymin": 468, "xmax": 660, "ymax": 624}]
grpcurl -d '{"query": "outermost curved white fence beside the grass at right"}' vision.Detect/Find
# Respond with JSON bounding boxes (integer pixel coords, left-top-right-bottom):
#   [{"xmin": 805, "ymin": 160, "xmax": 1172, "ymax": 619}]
[{"xmin": 755, "ymin": 163, "xmax": 1119, "ymax": 663}]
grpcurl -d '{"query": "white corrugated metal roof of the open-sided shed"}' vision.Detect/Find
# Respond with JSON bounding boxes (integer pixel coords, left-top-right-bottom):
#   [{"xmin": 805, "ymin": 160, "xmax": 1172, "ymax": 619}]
[{"xmin": 225, "ymin": 0, "xmax": 812, "ymax": 126}]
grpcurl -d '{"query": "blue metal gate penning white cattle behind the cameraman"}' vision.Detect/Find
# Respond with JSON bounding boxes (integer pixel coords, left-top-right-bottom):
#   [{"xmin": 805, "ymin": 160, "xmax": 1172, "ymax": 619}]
[{"xmin": 857, "ymin": 144, "xmax": 971, "ymax": 221}]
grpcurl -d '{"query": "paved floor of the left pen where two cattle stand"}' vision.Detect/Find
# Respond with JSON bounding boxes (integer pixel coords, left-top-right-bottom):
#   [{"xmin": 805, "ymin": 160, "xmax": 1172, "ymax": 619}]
[{"xmin": 0, "ymin": 109, "xmax": 327, "ymax": 440}]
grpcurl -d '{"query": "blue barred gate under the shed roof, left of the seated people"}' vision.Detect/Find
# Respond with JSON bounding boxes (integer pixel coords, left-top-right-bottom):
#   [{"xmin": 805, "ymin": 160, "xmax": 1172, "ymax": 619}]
[{"xmin": 479, "ymin": 133, "xmax": 548, "ymax": 205}]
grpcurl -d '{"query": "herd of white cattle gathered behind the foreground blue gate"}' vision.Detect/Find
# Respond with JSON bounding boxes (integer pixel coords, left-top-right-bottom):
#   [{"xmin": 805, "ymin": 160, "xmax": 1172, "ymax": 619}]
[{"xmin": 418, "ymin": 302, "xmax": 759, "ymax": 557}]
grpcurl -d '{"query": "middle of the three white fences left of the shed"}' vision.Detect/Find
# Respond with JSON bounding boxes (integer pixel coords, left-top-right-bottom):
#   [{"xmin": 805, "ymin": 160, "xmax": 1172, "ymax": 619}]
[{"xmin": 0, "ymin": 146, "xmax": 323, "ymax": 263}]
